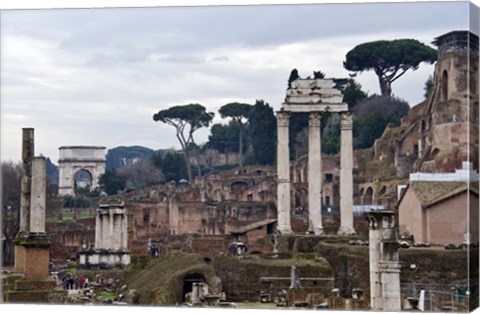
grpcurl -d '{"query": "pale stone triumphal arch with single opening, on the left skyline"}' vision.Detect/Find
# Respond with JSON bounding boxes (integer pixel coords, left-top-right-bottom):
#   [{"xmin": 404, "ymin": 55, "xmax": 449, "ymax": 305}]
[{"xmin": 58, "ymin": 146, "xmax": 106, "ymax": 196}]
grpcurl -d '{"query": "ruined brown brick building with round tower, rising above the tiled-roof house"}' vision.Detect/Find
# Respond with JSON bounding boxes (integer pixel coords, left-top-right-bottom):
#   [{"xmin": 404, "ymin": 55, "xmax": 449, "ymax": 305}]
[{"xmin": 355, "ymin": 31, "xmax": 479, "ymax": 208}]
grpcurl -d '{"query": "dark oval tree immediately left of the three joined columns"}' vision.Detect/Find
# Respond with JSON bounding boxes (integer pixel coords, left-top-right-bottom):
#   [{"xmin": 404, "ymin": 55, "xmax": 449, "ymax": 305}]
[{"xmin": 250, "ymin": 100, "xmax": 277, "ymax": 165}]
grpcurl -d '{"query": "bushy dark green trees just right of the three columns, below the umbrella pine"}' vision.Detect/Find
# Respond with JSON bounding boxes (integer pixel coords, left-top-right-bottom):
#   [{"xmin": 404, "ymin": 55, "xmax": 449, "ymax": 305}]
[{"xmin": 353, "ymin": 95, "xmax": 410, "ymax": 149}]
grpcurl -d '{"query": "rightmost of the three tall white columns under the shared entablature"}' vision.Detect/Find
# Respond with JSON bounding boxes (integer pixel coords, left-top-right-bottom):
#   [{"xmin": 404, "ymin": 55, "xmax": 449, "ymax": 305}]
[{"xmin": 338, "ymin": 112, "xmax": 355, "ymax": 235}]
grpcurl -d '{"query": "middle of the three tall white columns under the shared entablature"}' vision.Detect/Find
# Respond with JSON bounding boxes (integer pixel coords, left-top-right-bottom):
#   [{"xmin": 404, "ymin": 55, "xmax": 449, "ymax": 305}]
[{"xmin": 308, "ymin": 112, "xmax": 323, "ymax": 235}]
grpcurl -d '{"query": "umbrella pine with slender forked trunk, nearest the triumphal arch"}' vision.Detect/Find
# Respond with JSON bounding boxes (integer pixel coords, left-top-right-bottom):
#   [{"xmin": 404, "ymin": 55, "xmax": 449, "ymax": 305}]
[{"xmin": 153, "ymin": 104, "xmax": 214, "ymax": 182}]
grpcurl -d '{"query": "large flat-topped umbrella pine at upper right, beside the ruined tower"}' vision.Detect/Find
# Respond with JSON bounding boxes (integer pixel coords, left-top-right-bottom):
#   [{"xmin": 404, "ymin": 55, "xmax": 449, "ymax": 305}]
[{"xmin": 343, "ymin": 39, "xmax": 437, "ymax": 96}]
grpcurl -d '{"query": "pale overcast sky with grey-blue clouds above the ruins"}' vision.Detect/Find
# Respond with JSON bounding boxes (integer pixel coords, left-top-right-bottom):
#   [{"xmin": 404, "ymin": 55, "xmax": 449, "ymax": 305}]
[{"xmin": 0, "ymin": 2, "xmax": 469, "ymax": 163}]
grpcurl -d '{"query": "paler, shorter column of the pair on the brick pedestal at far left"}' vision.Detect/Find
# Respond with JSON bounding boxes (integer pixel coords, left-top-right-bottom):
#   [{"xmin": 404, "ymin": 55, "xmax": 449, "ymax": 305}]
[{"xmin": 30, "ymin": 157, "xmax": 47, "ymax": 234}]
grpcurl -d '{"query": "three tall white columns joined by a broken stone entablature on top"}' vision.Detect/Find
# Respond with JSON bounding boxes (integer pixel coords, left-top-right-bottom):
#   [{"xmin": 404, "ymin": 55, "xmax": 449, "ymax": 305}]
[{"xmin": 277, "ymin": 79, "xmax": 355, "ymax": 235}]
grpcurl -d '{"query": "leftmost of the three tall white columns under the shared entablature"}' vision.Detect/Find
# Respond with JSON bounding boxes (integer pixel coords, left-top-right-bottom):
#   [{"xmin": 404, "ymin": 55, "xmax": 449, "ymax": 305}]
[{"xmin": 277, "ymin": 111, "xmax": 293, "ymax": 234}]
